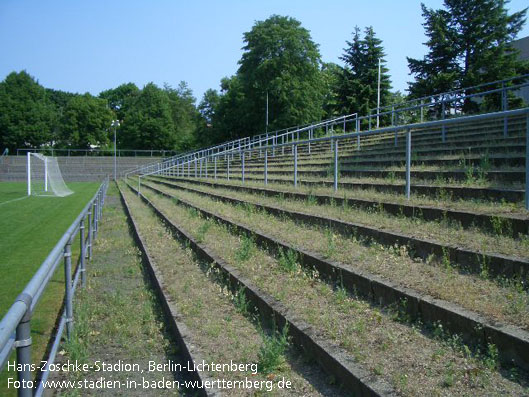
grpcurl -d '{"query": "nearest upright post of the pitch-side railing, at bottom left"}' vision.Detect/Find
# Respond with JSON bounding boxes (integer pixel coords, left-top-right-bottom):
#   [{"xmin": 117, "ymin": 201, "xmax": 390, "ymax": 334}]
[{"xmin": 15, "ymin": 294, "xmax": 33, "ymax": 397}]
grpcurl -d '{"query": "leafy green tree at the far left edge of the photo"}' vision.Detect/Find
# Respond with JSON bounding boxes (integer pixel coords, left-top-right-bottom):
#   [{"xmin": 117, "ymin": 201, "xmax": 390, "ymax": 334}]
[{"xmin": 0, "ymin": 71, "xmax": 57, "ymax": 151}]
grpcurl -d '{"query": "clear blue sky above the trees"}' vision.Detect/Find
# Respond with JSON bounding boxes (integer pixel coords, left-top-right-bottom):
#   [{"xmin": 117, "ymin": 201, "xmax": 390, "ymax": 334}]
[{"xmin": 0, "ymin": 0, "xmax": 529, "ymax": 100}]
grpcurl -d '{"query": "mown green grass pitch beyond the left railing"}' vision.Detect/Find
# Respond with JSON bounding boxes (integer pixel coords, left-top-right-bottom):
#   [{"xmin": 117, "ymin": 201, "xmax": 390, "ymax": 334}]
[{"xmin": 0, "ymin": 182, "xmax": 99, "ymax": 390}]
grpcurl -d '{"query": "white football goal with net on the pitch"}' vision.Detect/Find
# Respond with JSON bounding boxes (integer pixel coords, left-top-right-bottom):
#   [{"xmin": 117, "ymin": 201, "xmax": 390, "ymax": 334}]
[{"xmin": 27, "ymin": 153, "xmax": 73, "ymax": 197}]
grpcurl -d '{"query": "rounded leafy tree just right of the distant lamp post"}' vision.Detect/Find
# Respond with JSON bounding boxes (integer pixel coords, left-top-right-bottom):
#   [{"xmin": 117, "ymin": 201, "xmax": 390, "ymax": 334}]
[{"xmin": 118, "ymin": 83, "xmax": 177, "ymax": 149}]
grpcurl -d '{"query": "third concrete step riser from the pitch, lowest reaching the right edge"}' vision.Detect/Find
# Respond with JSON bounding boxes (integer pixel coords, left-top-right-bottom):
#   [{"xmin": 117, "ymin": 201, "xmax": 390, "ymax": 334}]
[{"xmin": 139, "ymin": 181, "xmax": 529, "ymax": 369}]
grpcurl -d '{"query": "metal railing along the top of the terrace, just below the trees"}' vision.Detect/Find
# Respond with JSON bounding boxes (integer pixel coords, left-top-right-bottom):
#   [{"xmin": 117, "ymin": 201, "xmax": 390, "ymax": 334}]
[{"xmin": 127, "ymin": 75, "xmax": 529, "ymax": 177}]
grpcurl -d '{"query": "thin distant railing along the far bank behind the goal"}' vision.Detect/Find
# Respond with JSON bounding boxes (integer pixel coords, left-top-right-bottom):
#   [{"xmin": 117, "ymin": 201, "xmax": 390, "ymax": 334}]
[{"xmin": 17, "ymin": 148, "xmax": 178, "ymax": 157}]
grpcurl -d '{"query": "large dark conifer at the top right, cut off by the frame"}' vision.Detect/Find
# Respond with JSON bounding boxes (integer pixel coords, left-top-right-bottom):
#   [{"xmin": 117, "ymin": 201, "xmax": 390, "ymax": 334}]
[{"xmin": 408, "ymin": 0, "xmax": 528, "ymax": 97}]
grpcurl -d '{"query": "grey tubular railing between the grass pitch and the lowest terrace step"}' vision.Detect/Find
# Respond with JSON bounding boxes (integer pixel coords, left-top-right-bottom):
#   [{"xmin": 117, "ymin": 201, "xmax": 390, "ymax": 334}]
[{"xmin": 0, "ymin": 178, "xmax": 108, "ymax": 397}]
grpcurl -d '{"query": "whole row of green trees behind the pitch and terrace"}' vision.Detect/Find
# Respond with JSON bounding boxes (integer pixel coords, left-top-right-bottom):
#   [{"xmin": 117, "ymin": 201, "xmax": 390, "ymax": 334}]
[{"xmin": 0, "ymin": 8, "xmax": 529, "ymax": 155}]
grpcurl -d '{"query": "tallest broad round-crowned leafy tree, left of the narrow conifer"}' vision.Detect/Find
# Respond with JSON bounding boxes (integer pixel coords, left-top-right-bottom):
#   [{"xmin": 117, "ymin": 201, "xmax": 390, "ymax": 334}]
[{"xmin": 237, "ymin": 15, "xmax": 323, "ymax": 135}]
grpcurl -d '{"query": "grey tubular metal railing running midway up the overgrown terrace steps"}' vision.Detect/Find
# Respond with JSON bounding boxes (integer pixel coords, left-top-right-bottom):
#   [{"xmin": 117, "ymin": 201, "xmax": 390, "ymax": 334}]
[{"xmin": 138, "ymin": 108, "xmax": 529, "ymax": 210}]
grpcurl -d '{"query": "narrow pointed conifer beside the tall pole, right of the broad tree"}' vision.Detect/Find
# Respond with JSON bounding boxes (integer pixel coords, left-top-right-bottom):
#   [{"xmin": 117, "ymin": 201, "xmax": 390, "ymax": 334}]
[{"xmin": 338, "ymin": 27, "xmax": 391, "ymax": 120}]
